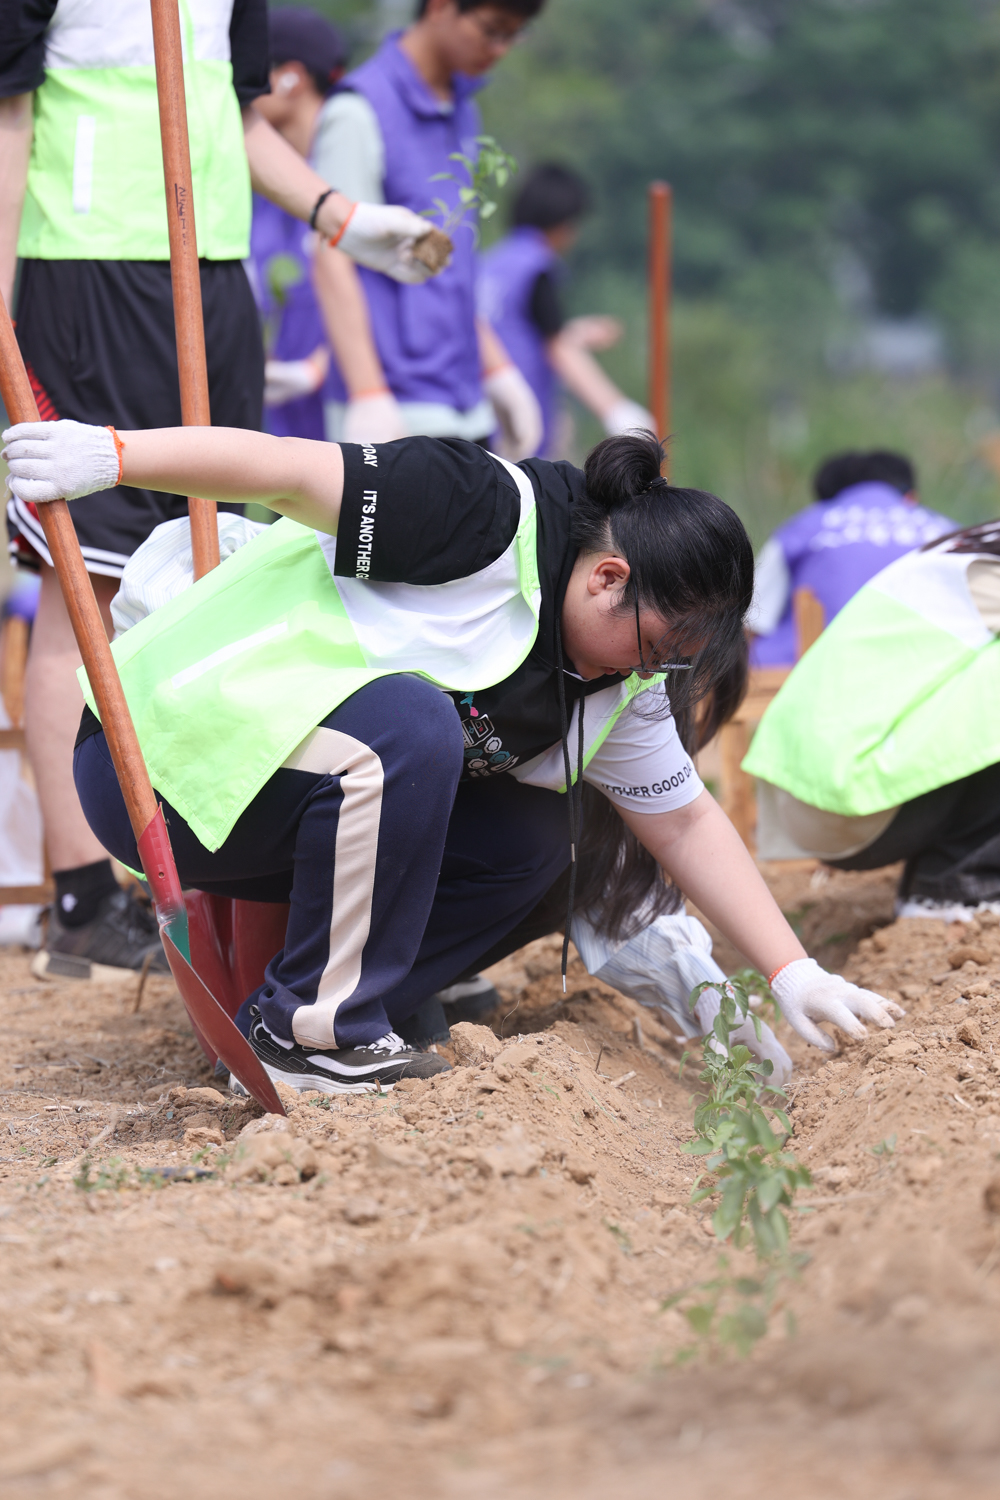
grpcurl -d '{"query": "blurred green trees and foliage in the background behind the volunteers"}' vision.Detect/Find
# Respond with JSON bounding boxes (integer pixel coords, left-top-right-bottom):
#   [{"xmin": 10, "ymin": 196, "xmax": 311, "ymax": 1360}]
[{"xmin": 275, "ymin": 0, "xmax": 1000, "ymax": 543}]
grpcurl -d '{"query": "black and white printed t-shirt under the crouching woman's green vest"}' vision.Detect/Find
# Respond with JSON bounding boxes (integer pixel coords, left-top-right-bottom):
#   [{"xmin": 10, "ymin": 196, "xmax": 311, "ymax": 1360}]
[{"xmin": 329, "ymin": 438, "xmax": 702, "ymax": 812}]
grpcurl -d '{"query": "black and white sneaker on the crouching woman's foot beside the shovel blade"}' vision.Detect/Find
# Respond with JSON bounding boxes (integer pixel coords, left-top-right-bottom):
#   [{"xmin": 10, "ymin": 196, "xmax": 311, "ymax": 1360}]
[{"xmin": 239, "ymin": 1005, "xmax": 451, "ymax": 1094}]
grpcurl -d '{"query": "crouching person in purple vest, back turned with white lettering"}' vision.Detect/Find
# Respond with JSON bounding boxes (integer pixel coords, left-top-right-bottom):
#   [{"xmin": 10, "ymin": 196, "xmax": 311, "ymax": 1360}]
[{"xmin": 747, "ymin": 449, "xmax": 955, "ymax": 666}]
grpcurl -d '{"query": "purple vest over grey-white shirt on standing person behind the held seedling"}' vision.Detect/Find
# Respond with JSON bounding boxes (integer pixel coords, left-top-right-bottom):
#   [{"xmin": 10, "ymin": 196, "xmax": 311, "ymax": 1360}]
[{"xmin": 342, "ymin": 33, "xmax": 483, "ymax": 411}]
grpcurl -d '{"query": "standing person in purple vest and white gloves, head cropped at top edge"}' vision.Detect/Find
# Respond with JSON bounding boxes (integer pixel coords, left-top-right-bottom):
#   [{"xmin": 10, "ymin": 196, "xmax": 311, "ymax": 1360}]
[{"xmin": 313, "ymin": 0, "xmax": 544, "ymax": 459}]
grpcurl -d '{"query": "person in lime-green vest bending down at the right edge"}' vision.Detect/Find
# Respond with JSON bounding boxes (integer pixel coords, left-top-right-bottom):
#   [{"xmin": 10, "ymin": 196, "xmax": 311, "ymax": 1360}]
[{"xmin": 744, "ymin": 521, "xmax": 1000, "ymax": 921}]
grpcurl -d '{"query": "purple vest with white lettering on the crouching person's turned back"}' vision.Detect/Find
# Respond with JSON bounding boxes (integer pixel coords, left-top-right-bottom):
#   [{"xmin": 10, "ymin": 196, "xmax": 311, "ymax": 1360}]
[{"xmin": 751, "ymin": 483, "xmax": 955, "ymax": 666}]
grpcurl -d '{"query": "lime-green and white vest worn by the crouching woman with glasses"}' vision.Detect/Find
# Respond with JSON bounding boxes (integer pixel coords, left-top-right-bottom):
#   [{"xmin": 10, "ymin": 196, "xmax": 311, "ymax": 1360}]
[{"xmin": 79, "ymin": 465, "xmax": 661, "ymax": 851}]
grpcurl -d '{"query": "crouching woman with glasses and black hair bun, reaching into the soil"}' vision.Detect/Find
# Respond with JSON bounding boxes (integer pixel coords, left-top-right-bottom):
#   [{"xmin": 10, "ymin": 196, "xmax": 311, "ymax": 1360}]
[{"xmin": 4, "ymin": 422, "xmax": 901, "ymax": 1092}]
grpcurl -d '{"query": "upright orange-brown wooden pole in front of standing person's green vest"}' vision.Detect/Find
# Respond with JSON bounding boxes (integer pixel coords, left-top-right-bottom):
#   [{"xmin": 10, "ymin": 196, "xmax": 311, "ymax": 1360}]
[{"xmin": 150, "ymin": 0, "xmax": 219, "ymax": 578}]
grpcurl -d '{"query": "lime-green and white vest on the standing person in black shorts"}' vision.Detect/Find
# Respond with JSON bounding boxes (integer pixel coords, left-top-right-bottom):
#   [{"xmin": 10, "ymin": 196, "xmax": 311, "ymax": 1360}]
[{"xmin": 18, "ymin": 0, "xmax": 250, "ymax": 261}]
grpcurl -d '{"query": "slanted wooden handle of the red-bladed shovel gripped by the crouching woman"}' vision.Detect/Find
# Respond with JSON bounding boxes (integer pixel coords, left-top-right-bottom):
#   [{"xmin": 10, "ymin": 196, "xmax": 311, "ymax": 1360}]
[{"xmin": 0, "ymin": 300, "xmax": 156, "ymax": 839}]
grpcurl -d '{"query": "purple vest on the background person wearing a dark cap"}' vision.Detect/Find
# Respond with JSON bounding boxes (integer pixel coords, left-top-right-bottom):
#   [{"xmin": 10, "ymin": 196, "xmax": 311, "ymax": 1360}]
[{"xmin": 250, "ymin": 194, "xmax": 334, "ymax": 440}]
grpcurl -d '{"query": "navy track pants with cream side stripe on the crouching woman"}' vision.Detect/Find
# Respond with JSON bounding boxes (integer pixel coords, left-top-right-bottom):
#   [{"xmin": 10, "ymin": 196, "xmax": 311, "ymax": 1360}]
[{"xmin": 73, "ymin": 675, "xmax": 570, "ymax": 1047}]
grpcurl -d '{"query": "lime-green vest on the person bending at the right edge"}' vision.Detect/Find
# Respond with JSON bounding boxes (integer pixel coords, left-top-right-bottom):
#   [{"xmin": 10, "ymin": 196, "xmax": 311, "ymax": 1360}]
[{"xmin": 744, "ymin": 543, "xmax": 1000, "ymax": 818}]
